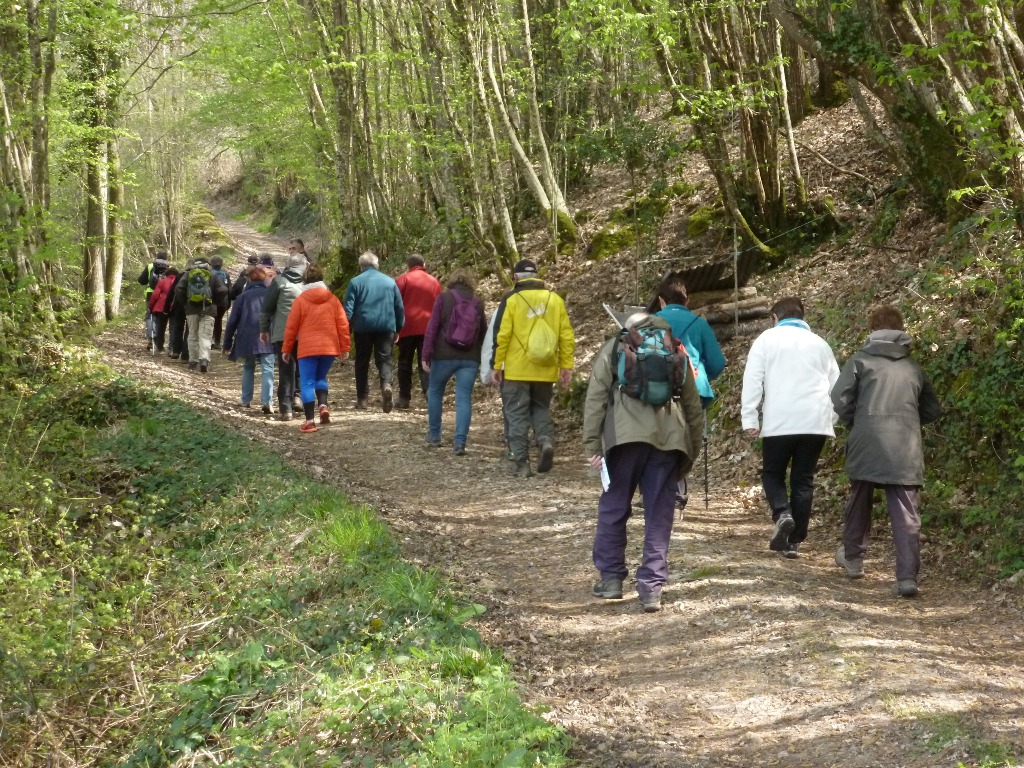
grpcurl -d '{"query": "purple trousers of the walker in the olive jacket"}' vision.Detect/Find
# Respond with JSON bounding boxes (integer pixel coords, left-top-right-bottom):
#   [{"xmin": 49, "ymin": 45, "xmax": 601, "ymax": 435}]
[{"xmin": 594, "ymin": 442, "xmax": 680, "ymax": 597}]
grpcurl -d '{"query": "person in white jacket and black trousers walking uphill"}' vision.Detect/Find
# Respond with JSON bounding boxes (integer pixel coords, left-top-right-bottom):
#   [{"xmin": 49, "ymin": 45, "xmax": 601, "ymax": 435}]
[{"xmin": 740, "ymin": 297, "xmax": 839, "ymax": 558}]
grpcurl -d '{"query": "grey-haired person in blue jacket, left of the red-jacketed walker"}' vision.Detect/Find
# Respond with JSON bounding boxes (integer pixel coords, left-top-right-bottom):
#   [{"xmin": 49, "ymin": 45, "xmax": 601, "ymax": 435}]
[{"xmin": 345, "ymin": 251, "xmax": 406, "ymax": 414}]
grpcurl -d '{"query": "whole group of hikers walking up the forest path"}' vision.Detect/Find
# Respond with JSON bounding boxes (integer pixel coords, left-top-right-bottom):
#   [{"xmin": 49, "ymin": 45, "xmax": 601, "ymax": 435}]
[{"xmin": 139, "ymin": 246, "xmax": 939, "ymax": 611}]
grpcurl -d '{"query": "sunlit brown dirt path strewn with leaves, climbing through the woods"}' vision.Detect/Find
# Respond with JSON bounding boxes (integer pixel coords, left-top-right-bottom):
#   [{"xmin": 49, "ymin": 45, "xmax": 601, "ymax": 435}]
[{"xmin": 99, "ymin": 222, "xmax": 1024, "ymax": 768}]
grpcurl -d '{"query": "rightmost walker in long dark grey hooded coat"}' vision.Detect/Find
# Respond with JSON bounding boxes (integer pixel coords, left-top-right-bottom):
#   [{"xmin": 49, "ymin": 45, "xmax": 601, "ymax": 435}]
[{"xmin": 831, "ymin": 305, "xmax": 940, "ymax": 597}]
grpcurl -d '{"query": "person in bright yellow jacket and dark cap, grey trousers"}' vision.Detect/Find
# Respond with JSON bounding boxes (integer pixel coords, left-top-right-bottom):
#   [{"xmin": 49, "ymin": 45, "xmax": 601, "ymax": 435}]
[{"xmin": 490, "ymin": 259, "xmax": 575, "ymax": 477}]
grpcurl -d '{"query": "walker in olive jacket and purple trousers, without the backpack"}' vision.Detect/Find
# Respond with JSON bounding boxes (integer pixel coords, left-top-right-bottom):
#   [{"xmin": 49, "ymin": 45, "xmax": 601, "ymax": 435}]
[{"xmin": 583, "ymin": 312, "xmax": 703, "ymax": 611}]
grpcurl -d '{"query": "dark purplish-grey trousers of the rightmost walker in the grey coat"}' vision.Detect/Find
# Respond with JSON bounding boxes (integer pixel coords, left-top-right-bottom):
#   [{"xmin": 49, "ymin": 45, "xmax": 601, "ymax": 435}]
[{"xmin": 843, "ymin": 480, "xmax": 921, "ymax": 581}]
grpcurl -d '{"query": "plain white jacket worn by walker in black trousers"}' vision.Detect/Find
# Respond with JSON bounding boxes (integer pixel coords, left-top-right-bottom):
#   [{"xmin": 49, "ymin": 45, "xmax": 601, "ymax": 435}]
[{"xmin": 740, "ymin": 319, "xmax": 839, "ymax": 437}]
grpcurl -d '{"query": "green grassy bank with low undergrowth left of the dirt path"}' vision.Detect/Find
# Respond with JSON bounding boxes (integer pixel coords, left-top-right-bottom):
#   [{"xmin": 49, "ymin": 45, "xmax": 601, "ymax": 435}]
[{"xmin": 0, "ymin": 361, "xmax": 567, "ymax": 768}]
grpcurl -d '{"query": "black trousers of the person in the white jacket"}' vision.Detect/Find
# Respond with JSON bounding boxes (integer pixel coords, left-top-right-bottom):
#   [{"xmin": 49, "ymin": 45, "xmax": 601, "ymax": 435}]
[{"xmin": 761, "ymin": 434, "xmax": 825, "ymax": 544}]
